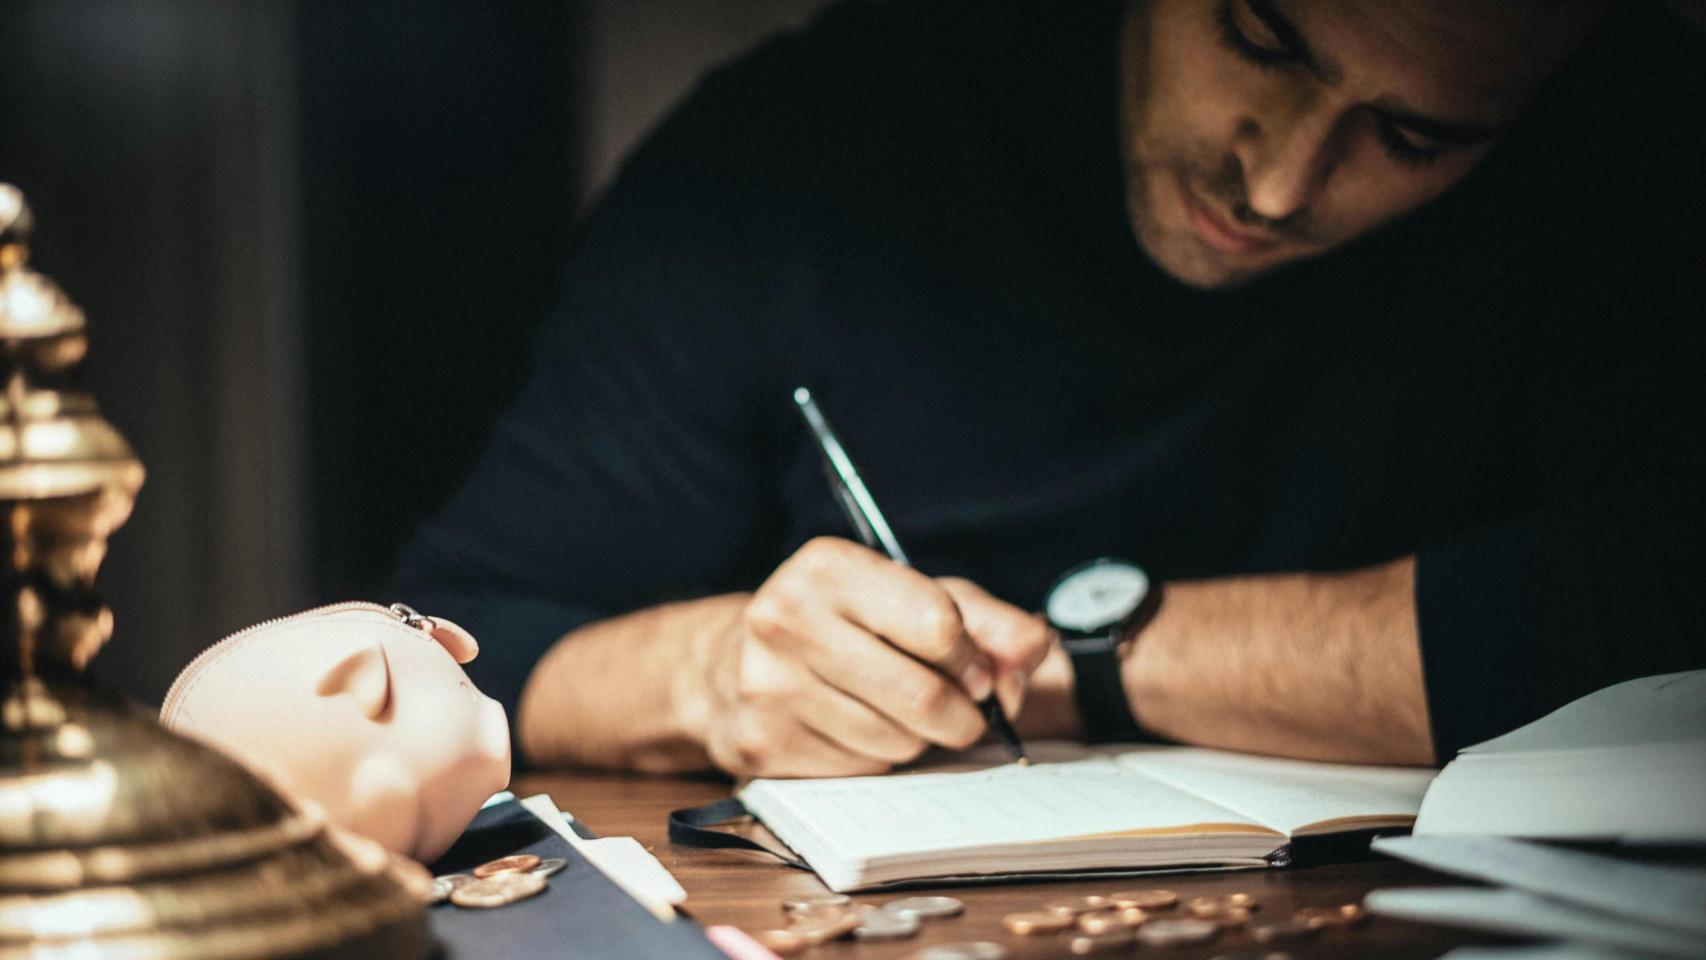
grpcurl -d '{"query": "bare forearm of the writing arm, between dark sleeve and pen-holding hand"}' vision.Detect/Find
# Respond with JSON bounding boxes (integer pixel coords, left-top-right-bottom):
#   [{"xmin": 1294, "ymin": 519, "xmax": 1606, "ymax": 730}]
[{"xmin": 519, "ymin": 593, "xmax": 749, "ymax": 772}]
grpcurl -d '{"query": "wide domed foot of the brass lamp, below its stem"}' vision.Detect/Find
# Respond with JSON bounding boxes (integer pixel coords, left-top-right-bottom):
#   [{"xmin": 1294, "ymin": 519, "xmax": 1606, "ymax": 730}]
[{"xmin": 0, "ymin": 679, "xmax": 433, "ymax": 960}]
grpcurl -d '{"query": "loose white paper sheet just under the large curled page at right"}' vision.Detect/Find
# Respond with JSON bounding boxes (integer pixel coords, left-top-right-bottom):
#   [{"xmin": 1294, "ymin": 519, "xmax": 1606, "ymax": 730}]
[{"xmin": 1373, "ymin": 837, "xmax": 1706, "ymax": 936}]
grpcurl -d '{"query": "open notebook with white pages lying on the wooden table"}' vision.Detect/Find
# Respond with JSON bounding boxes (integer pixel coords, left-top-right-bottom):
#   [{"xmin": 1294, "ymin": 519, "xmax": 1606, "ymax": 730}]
[{"xmin": 740, "ymin": 747, "xmax": 1433, "ymax": 890}]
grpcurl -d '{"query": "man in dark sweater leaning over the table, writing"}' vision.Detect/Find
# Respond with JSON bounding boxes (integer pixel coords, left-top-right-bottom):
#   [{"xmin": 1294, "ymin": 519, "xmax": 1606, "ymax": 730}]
[{"xmin": 403, "ymin": 0, "xmax": 1706, "ymax": 776}]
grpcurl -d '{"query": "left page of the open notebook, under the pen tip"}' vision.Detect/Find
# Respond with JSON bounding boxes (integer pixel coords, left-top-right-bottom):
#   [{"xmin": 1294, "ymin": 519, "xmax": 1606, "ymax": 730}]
[{"xmin": 740, "ymin": 759, "xmax": 1264, "ymax": 861}]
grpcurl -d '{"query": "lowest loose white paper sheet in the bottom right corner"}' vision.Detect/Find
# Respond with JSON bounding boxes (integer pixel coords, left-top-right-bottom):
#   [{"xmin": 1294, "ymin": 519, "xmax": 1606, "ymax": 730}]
[{"xmin": 1363, "ymin": 887, "xmax": 1706, "ymax": 960}]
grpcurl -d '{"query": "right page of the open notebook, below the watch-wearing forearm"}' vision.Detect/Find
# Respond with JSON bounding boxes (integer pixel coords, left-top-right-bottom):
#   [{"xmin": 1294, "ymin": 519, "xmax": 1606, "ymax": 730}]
[{"xmin": 1116, "ymin": 747, "xmax": 1435, "ymax": 836}]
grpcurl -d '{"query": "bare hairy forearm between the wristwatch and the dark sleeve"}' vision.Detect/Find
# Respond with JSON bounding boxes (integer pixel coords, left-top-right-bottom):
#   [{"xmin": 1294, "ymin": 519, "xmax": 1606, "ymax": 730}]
[{"xmin": 1121, "ymin": 558, "xmax": 1433, "ymax": 764}]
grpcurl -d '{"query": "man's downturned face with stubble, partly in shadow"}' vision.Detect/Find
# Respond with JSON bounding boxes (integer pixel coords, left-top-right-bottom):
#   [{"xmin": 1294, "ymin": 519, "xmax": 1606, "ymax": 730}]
[{"xmin": 1119, "ymin": 0, "xmax": 1592, "ymax": 288}]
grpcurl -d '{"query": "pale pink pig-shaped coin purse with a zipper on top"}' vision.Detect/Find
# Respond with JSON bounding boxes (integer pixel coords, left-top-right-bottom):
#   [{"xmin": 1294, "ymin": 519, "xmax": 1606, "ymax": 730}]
[{"xmin": 160, "ymin": 604, "xmax": 510, "ymax": 861}]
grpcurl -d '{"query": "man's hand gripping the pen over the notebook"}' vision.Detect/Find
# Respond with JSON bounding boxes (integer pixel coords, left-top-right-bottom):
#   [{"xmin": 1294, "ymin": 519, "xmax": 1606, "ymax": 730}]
[{"xmin": 692, "ymin": 537, "xmax": 1053, "ymax": 776}]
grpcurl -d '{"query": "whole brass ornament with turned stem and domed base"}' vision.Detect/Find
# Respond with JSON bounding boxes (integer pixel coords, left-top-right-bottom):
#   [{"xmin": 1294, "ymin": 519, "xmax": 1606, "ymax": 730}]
[{"xmin": 0, "ymin": 184, "xmax": 433, "ymax": 960}]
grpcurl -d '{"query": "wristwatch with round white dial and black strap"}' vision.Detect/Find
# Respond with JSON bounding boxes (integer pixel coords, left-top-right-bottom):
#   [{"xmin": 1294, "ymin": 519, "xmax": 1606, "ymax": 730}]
[{"xmin": 1044, "ymin": 558, "xmax": 1162, "ymax": 743}]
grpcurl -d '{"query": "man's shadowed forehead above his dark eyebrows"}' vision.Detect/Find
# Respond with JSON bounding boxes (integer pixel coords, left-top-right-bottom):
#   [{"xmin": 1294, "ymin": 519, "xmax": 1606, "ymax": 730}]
[{"xmin": 1282, "ymin": 0, "xmax": 1593, "ymax": 123}]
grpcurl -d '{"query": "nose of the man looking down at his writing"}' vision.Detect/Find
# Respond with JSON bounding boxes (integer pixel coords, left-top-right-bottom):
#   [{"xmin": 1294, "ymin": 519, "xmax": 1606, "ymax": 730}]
[{"xmin": 1235, "ymin": 102, "xmax": 1338, "ymax": 220}]
